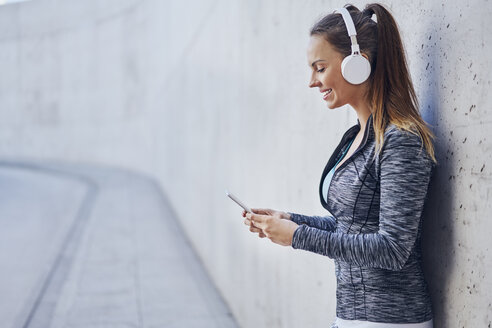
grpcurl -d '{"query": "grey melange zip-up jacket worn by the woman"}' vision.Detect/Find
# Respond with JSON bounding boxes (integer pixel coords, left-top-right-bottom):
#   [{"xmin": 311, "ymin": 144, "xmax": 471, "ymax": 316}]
[{"xmin": 289, "ymin": 115, "xmax": 435, "ymax": 323}]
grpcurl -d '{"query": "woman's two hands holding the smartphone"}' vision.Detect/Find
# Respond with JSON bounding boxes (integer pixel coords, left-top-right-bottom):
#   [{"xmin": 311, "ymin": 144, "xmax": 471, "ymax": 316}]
[{"xmin": 243, "ymin": 209, "xmax": 298, "ymax": 246}]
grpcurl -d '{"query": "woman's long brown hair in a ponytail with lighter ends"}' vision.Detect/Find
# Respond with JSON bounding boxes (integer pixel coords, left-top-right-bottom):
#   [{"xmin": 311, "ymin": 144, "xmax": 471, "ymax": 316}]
[{"xmin": 310, "ymin": 3, "xmax": 437, "ymax": 163}]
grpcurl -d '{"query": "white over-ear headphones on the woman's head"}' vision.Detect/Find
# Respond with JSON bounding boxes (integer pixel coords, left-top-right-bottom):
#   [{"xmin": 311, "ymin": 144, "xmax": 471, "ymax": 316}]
[{"xmin": 335, "ymin": 8, "xmax": 371, "ymax": 84}]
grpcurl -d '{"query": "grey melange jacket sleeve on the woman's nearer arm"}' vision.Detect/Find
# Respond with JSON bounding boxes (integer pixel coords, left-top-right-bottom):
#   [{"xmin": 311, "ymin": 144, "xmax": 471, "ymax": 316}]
[{"xmin": 292, "ymin": 130, "xmax": 433, "ymax": 270}]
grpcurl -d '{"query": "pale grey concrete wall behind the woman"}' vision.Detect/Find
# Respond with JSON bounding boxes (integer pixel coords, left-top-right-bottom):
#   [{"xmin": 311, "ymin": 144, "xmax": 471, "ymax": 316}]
[{"xmin": 0, "ymin": 0, "xmax": 492, "ymax": 327}]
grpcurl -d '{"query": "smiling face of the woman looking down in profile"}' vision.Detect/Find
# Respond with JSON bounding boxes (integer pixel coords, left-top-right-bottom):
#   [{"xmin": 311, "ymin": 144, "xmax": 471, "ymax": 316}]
[{"xmin": 307, "ymin": 34, "xmax": 366, "ymax": 108}]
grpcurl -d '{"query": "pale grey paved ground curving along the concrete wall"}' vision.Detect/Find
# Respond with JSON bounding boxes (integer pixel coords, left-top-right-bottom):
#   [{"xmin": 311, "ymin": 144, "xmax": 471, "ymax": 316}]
[{"xmin": 0, "ymin": 161, "xmax": 237, "ymax": 328}]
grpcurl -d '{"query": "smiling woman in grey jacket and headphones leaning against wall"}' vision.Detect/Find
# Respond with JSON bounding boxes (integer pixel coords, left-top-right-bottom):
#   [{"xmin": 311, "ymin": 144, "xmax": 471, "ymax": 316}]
[{"xmin": 243, "ymin": 4, "xmax": 437, "ymax": 328}]
